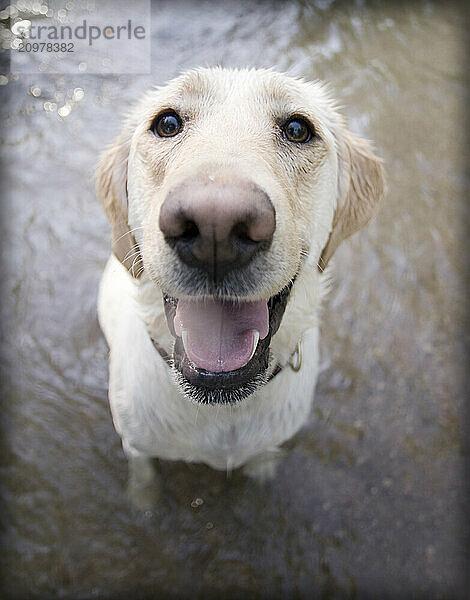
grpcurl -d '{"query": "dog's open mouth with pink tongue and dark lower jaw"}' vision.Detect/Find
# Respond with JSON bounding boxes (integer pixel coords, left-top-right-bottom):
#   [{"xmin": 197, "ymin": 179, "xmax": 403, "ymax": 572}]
[{"xmin": 163, "ymin": 282, "xmax": 293, "ymax": 404}]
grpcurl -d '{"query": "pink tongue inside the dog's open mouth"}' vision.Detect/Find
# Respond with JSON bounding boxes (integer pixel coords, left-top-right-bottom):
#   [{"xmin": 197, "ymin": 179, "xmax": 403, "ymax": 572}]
[{"xmin": 174, "ymin": 300, "xmax": 269, "ymax": 373}]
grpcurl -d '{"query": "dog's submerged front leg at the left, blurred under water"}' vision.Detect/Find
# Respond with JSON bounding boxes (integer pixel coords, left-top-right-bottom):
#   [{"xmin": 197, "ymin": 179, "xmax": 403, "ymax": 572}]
[{"xmin": 127, "ymin": 457, "xmax": 161, "ymax": 512}]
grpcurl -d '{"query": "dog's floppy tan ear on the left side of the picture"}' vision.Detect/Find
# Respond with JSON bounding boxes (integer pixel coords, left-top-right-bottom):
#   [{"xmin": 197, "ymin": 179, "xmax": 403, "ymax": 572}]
[{"xmin": 96, "ymin": 132, "xmax": 141, "ymax": 277}]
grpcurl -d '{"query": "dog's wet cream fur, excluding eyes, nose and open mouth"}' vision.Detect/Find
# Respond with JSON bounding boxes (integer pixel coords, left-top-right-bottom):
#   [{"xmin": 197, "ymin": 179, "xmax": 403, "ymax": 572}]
[{"xmin": 97, "ymin": 68, "xmax": 383, "ymax": 504}]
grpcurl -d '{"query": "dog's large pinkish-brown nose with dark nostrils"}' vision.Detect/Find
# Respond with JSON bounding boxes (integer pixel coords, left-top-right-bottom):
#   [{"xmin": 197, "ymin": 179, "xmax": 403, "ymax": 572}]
[{"xmin": 159, "ymin": 177, "xmax": 276, "ymax": 281}]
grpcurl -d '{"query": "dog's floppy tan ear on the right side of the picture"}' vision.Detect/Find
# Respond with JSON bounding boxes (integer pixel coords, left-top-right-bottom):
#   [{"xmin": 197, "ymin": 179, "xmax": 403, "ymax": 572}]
[{"xmin": 319, "ymin": 126, "xmax": 385, "ymax": 271}]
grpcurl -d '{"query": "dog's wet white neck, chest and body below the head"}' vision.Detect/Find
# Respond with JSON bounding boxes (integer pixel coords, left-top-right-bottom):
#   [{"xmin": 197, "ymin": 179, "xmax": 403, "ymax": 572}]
[{"xmin": 98, "ymin": 256, "xmax": 321, "ymax": 470}]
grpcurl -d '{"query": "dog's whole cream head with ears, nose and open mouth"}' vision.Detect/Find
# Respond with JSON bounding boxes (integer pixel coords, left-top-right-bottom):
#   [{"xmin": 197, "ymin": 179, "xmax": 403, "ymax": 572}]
[{"xmin": 97, "ymin": 68, "xmax": 384, "ymax": 402}]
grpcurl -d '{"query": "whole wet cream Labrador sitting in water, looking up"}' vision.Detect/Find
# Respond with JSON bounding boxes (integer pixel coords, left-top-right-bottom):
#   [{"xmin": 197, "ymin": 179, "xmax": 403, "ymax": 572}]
[{"xmin": 96, "ymin": 67, "xmax": 385, "ymax": 508}]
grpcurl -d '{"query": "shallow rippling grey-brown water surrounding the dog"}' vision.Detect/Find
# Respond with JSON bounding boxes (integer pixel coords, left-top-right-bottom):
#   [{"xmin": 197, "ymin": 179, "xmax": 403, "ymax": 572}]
[{"xmin": 1, "ymin": 0, "xmax": 469, "ymax": 599}]
